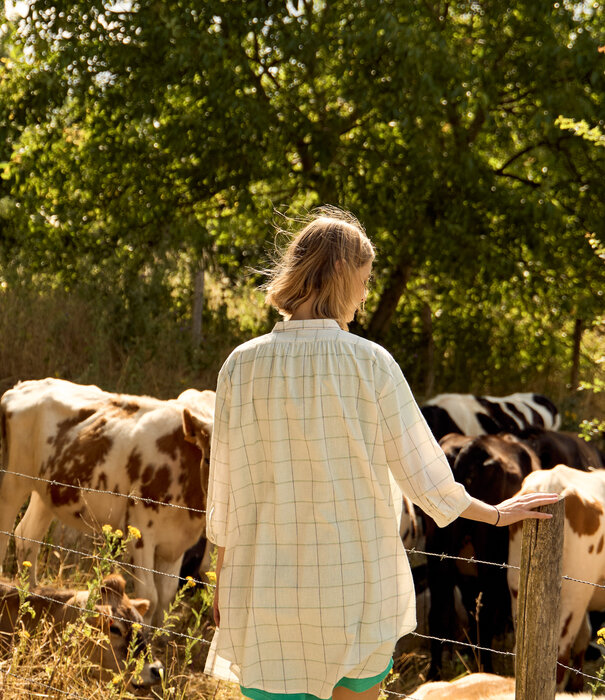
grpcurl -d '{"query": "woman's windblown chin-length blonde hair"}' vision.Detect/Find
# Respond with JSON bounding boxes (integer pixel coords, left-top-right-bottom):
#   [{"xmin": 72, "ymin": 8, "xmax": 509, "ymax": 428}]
[{"xmin": 263, "ymin": 207, "xmax": 374, "ymax": 329}]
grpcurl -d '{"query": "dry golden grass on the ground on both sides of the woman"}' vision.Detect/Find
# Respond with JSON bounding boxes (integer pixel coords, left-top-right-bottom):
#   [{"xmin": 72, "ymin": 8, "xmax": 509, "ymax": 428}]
[{"xmin": 0, "ymin": 572, "xmax": 603, "ymax": 700}]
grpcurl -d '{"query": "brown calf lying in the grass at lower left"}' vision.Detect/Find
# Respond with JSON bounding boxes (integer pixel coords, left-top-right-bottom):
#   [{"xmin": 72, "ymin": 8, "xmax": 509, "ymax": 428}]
[{"xmin": 0, "ymin": 574, "xmax": 163, "ymax": 687}]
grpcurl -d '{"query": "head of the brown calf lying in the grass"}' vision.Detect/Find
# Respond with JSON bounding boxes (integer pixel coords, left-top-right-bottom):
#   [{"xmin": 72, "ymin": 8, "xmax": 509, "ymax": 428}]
[{"xmin": 66, "ymin": 574, "xmax": 164, "ymax": 687}]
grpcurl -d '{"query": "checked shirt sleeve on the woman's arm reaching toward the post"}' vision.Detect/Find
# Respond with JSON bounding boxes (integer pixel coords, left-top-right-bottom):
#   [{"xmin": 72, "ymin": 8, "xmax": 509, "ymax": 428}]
[{"xmin": 378, "ymin": 360, "xmax": 471, "ymax": 527}]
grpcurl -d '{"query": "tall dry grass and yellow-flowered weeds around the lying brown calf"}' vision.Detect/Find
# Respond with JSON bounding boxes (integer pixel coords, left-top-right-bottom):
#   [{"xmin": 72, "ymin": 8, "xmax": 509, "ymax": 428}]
[{"xmin": 0, "ymin": 526, "xmax": 213, "ymax": 700}]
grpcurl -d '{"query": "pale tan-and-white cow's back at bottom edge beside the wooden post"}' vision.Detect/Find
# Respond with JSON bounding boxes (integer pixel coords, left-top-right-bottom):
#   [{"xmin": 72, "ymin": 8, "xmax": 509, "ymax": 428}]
[{"xmin": 409, "ymin": 673, "xmax": 594, "ymax": 700}]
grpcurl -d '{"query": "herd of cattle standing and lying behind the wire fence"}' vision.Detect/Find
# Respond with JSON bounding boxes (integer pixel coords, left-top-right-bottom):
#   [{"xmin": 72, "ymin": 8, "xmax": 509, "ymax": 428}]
[{"xmin": 0, "ymin": 378, "xmax": 605, "ymax": 697}]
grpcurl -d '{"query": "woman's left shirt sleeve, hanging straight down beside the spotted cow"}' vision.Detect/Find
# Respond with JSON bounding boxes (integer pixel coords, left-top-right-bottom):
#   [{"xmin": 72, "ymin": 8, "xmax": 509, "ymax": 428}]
[{"xmin": 206, "ymin": 367, "xmax": 231, "ymax": 547}]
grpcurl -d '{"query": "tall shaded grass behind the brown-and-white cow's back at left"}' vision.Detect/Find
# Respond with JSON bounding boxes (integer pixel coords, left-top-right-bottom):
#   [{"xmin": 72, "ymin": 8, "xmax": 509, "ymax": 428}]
[{"xmin": 0, "ymin": 279, "xmax": 267, "ymax": 398}]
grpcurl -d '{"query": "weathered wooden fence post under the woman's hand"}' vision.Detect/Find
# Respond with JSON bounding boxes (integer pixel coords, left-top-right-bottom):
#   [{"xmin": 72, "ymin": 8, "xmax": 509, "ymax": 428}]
[{"xmin": 515, "ymin": 499, "xmax": 565, "ymax": 700}]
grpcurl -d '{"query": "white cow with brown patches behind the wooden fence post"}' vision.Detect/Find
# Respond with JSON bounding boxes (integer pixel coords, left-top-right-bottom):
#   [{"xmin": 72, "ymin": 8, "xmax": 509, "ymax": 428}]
[{"xmin": 508, "ymin": 464, "xmax": 605, "ymax": 690}]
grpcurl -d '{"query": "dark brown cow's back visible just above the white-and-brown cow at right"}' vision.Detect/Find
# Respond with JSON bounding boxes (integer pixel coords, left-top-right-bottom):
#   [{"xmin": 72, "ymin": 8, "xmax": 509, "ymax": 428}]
[{"xmin": 519, "ymin": 428, "xmax": 605, "ymax": 470}]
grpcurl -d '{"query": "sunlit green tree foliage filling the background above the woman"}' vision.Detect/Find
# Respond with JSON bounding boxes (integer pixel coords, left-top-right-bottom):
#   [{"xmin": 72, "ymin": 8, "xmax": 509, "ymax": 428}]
[{"xmin": 0, "ymin": 0, "xmax": 605, "ymax": 390}]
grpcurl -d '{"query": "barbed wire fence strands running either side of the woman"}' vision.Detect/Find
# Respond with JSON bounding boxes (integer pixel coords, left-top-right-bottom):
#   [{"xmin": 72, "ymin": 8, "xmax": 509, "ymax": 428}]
[{"xmin": 0, "ymin": 468, "xmax": 605, "ymax": 700}]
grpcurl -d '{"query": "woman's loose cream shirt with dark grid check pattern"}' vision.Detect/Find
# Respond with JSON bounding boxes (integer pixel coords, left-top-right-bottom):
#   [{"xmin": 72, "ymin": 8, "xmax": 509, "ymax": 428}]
[{"xmin": 206, "ymin": 319, "xmax": 470, "ymax": 698}]
